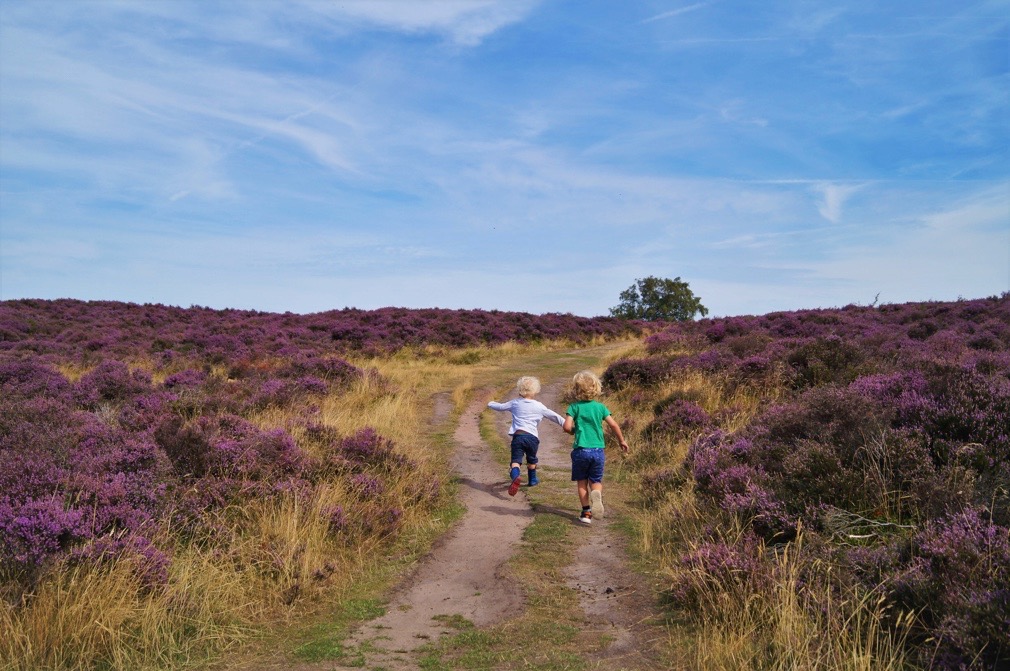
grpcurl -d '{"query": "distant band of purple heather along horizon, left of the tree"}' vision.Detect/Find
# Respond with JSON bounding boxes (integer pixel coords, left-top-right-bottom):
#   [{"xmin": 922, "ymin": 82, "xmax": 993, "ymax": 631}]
[{"xmin": 0, "ymin": 300, "xmax": 642, "ymax": 361}]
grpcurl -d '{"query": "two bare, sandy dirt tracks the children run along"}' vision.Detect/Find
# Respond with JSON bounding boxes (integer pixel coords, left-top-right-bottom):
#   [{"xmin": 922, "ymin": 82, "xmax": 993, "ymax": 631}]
[{"xmin": 243, "ymin": 369, "xmax": 658, "ymax": 671}]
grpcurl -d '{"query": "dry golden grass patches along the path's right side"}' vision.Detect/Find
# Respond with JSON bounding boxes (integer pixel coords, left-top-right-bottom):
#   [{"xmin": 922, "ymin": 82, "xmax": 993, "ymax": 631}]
[{"xmin": 608, "ymin": 355, "xmax": 910, "ymax": 671}]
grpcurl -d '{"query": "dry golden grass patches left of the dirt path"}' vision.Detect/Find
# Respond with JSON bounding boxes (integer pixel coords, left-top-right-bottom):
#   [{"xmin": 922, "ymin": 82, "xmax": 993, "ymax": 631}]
[{"xmin": 0, "ymin": 343, "xmax": 614, "ymax": 671}]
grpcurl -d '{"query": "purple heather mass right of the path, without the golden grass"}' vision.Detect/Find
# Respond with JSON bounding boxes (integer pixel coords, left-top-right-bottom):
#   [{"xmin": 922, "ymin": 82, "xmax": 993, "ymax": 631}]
[{"xmin": 605, "ymin": 295, "xmax": 1010, "ymax": 669}]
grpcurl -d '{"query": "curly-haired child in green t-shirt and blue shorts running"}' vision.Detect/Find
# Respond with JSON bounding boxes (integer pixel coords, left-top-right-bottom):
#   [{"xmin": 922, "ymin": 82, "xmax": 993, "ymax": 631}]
[{"xmin": 564, "ymin": 371, "xmax": 629, "ymax": 524}]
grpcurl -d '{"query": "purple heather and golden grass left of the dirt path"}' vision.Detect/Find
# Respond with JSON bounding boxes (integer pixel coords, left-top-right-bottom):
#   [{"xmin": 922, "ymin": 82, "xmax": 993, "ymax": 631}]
[{"xmin": 0, "ymin": 300, "xmax": 639, "ymax": 670}]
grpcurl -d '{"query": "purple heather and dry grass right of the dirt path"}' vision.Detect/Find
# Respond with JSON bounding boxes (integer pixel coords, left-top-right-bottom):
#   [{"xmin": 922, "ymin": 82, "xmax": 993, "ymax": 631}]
[{"xmin": 603, "ymin": 294, "xmax": 1010, "ymax": 669}]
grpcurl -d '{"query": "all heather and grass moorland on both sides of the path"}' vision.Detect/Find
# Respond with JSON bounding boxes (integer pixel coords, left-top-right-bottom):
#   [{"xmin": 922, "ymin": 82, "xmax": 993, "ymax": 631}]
[{"xmin": 0, "ymin": 295, "xmax": 1010, "ymax": 670}]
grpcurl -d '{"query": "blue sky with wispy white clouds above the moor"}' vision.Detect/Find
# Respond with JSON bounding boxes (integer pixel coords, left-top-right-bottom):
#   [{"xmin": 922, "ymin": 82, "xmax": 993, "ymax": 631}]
[{"xmin": 0, "ymin": 0, "xmax": 1010, "ymax": 316}]
